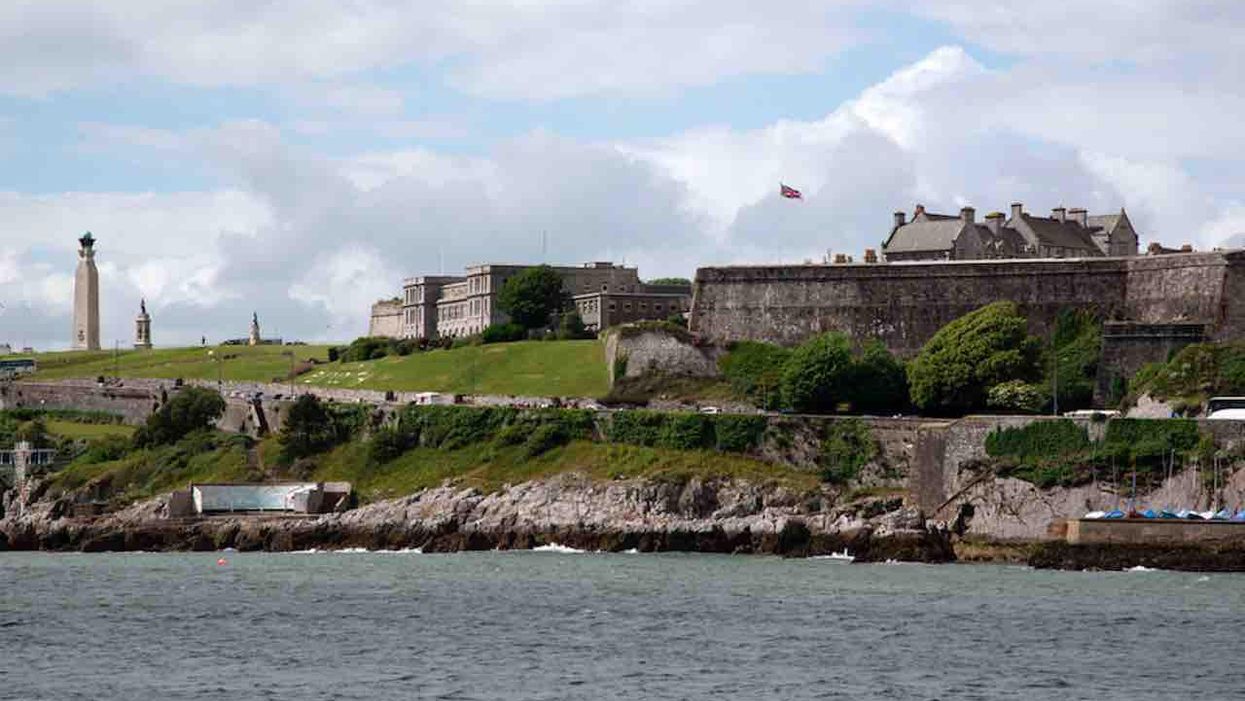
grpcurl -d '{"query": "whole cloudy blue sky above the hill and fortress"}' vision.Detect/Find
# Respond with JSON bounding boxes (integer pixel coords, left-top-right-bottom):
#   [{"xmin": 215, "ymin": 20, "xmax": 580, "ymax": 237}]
[{"xmin": 0, "ymin": 0, "xmax": 1245, "ymax": 350}]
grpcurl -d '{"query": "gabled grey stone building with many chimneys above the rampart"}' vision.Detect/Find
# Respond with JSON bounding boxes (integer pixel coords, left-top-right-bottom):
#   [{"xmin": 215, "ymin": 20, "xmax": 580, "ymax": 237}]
[{"xmin": 881, "ymin": 202, "xmax": 1138, "ymax": 263}]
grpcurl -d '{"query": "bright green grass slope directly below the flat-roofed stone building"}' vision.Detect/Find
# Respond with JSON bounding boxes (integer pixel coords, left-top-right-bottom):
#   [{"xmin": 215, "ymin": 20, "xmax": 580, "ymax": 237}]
[{"xmin": 298, "ymin": 341, "xmax": 609, "ymax": 397}]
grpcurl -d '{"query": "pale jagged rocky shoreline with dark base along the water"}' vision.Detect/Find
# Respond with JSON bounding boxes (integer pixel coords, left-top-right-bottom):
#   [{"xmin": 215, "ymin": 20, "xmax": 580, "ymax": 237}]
[{"xmin": 0, "ymin": 474, "xmax": 955, "ymax": 563}]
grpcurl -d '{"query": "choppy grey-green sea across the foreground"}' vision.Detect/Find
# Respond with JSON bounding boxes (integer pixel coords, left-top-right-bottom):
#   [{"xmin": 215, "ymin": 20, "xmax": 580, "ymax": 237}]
[{"xmin": 0, "ymin": 552, "xmax": 1245, "ymax": 701}]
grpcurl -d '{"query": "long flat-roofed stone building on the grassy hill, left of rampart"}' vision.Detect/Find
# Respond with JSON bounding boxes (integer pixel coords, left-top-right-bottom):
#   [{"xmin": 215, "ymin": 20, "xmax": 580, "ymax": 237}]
[{"xmin": 370, "ymin": 261, "xmax": 691, "ymax": 339}]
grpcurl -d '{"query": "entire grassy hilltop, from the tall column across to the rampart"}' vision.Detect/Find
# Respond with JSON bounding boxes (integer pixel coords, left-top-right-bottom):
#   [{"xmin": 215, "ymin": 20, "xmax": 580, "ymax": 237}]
[{"xmin": 14, "ymin": 341, "xmax": 609, "ymax": 397}]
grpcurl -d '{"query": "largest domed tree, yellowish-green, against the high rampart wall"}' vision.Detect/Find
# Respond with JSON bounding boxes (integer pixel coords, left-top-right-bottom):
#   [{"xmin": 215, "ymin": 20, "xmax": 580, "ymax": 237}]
[{"xmin": 908, "ymin": 301, "xmax": 1042, "ymax": 413}]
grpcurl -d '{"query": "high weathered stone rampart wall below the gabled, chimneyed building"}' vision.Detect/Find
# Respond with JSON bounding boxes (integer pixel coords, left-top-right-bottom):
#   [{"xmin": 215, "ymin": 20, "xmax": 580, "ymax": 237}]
[{"xmin": 691, "ymin": 252, "xmax": 1245, "ymax": 355}]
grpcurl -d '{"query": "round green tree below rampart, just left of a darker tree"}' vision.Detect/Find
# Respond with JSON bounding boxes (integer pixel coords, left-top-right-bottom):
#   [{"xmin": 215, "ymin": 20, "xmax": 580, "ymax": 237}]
[{"xmin": 781, "ymin": 332, "xmax": 853, "ymax": 411}]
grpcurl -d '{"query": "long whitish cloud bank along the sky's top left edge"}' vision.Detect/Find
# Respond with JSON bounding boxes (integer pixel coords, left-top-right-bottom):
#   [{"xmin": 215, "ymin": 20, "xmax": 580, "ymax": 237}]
[{"xmin": 0, "ymin": 0, "xmax": 857, "ymax": 100}]
